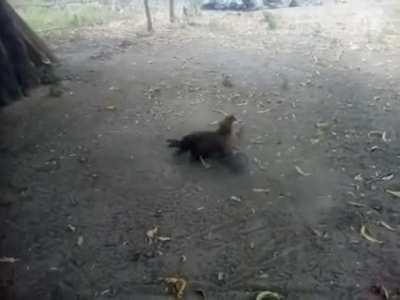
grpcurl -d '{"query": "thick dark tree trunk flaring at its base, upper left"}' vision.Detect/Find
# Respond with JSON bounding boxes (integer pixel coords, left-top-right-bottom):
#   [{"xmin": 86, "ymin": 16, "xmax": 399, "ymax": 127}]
[{"xmin": 0, "ymin": 0, "xmax": 57, "ymax": 107}]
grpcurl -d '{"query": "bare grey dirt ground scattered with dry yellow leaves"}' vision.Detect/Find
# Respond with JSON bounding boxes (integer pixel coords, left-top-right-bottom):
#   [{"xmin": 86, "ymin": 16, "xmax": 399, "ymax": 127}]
[{"xmin": 0, "ymin": 1, "xmax": 400, "ymax": 300}]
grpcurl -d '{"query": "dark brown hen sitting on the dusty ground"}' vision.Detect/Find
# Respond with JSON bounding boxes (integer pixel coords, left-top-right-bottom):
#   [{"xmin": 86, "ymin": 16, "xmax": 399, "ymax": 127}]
[{"xmin": 167, "ymin": 115, "xmax": 236, "ymax": 167}]
